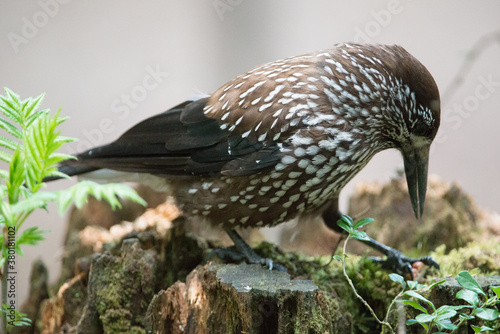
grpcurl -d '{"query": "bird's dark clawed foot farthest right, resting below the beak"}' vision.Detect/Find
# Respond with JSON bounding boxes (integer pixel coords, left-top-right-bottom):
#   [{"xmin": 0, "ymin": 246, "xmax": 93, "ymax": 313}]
[{"xmin": 370, "ymin": 248, "xmax": 439, "ymax": 280}]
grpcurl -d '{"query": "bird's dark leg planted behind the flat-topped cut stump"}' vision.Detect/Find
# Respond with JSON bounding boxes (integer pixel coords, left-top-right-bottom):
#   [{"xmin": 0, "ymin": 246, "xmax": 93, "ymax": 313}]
[{"xmin": 217, "ymin": 229, "xmax": 286, "ymax": 271}]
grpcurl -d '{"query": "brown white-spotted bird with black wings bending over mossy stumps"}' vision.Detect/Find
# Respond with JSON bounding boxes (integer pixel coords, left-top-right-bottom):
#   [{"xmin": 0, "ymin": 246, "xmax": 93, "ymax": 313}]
[{"xmin": 52, "ymin": 43, "xmax": 440, "ymax": 274}]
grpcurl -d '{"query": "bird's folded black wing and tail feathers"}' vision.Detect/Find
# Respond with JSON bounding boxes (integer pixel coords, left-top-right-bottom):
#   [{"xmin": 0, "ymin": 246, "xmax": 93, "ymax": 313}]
[{"xmin": 62, "ymin": 98, "xmax": 281, "ymax": 176}]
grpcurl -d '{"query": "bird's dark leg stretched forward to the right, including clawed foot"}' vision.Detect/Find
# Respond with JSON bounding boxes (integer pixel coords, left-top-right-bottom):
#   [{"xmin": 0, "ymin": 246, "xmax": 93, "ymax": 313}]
[{"xmin": 323, "ymin": 199, "xmax": 439, "ymax": 279}]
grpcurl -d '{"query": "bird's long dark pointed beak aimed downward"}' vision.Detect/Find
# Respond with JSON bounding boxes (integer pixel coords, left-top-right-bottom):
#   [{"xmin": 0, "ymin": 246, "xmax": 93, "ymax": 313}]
[{"xmin": 402, "ymin": 145, "xmax": 430, "ymax": 219}]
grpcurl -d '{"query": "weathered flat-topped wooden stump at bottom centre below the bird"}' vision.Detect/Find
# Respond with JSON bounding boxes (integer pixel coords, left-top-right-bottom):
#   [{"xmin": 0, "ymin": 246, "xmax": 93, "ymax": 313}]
[{"xmin": 146, "ymin": 264, "xmax": 350, "ymax": 333}]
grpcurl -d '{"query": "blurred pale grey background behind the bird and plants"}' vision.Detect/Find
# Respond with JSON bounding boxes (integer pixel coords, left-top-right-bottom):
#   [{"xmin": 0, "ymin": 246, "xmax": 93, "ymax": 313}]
[{"xmin": 0, "ymin": 0, "xmax": 500, "ymax": 305}]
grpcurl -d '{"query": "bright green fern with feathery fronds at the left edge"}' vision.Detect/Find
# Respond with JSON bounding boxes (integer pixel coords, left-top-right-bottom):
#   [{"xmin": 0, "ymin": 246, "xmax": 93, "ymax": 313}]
[{"xmin": 0, "ymin": 88, "xmax": 146, "ymax": 332}]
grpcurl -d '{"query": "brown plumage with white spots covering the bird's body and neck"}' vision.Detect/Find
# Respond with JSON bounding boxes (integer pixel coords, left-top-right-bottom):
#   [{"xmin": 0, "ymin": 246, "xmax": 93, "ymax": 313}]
[{"xmin": 176, "ymin": 44, "xmax": 436, "ymax": 230}]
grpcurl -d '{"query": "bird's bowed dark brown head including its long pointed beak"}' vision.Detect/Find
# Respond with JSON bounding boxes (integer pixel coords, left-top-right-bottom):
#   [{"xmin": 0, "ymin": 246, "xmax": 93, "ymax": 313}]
[{"xmin": 378, "ymin": 46, "xmax": 440, "ymax": 218}]
